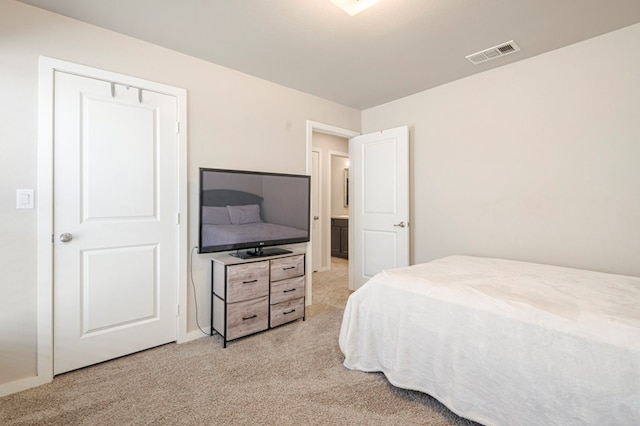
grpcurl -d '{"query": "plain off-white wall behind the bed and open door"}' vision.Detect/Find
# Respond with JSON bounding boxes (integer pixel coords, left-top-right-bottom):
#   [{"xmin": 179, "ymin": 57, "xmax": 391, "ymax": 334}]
[{"xmin": 362, "ymin": 24, "xmax": 640, "ymax": 276}]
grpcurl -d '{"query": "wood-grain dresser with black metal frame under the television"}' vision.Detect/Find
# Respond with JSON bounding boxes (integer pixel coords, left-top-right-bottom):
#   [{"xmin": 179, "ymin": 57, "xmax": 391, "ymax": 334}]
[{"xmin": 211, "ymin": 252, "xmax": 306, "ymax": 347}]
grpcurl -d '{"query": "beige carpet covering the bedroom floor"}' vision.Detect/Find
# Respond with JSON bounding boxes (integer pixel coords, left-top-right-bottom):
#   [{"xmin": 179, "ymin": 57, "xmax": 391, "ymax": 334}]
[{"xmin": 0, "ymin": 259, "xmax": 474, "ymax": 425}]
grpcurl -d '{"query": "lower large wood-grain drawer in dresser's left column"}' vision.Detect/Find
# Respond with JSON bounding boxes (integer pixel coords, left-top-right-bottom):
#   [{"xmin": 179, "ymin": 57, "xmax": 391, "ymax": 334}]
[{"xmin": 225, "ymin": 296, "xmax": 269, "ymax": 340}]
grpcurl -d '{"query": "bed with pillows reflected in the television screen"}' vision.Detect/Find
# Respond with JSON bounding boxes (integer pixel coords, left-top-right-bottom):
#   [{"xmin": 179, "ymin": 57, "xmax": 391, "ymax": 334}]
[{"xmin": 201, "ymin": 189, "xmax": 307, "ymax": 246}]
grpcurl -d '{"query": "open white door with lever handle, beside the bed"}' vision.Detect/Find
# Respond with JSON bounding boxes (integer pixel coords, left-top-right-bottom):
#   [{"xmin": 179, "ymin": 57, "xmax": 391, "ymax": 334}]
[{"xmin": 349, "ymin": 126, "xmax": 409, "ymax": 290}]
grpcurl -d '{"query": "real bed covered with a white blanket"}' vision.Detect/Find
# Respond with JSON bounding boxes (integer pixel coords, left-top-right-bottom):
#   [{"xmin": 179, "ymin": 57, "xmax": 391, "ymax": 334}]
[{"xmin": 339, "ymin": 256, "xmax": 640, "ymax": 426}]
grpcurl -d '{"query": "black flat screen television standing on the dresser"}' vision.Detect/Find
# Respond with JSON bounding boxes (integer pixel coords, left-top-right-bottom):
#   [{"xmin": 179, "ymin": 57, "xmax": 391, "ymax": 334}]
[{"xmin": 198, "ymin": 168, "xmax": 311, "ymax": 258}]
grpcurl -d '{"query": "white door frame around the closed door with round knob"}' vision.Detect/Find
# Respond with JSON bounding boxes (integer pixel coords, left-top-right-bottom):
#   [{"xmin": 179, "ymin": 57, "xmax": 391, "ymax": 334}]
[{"xmin": 34, "ymin": 56, "xmax": 189, "ymax": 389}]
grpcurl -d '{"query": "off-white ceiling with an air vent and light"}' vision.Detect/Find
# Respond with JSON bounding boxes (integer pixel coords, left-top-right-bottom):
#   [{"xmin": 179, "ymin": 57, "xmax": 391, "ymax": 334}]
[{"xmin": 20, "ymin": 0, "xmax": 640, "ymax": 109}]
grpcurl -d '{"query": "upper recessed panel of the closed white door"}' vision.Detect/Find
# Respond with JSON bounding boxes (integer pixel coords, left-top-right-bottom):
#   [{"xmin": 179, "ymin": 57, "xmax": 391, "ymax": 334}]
[{"xmin": 82, "ymin": 98, "xmax": 157, "ymax": 220}]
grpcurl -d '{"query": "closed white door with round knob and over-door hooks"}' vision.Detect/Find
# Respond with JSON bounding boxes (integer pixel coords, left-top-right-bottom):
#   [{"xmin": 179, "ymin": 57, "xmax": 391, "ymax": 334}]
[{"xmin": 53, "ymin": 72, "xmax": 178, "ymax": 374}]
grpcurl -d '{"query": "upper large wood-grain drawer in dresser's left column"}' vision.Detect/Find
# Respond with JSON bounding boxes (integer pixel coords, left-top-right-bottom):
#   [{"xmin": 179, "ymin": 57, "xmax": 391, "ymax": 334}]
[{"xmin": 226, "ymin": 262, "xmax": 269, "ymax": 303}]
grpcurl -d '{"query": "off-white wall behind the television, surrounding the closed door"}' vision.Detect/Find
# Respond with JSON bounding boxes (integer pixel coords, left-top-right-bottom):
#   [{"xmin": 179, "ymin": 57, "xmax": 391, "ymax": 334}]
[{"xmin": 0, "ymin": 0, "xmax": 360, "ymax": 393}]
